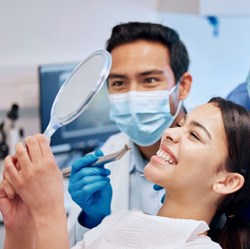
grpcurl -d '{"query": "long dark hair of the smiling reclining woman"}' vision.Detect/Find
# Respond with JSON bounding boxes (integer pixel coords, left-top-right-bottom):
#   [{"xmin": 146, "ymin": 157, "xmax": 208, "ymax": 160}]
[{"xmin": 209, "ymin": 97, "xmax": 250, "ymax": 249}]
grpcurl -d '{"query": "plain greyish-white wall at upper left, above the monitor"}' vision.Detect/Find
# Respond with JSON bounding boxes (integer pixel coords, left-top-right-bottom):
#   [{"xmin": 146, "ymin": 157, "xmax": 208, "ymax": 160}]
[{"xmin": 0, "ymin": 0, "xmax": 156, "ymax": 65}]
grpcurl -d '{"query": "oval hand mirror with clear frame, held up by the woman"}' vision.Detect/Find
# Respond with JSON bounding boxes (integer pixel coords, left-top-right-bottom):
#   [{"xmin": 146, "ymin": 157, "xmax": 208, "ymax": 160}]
[{"xmin": 44, "ymin": 50, "xmax": 112, "ymax": 138}]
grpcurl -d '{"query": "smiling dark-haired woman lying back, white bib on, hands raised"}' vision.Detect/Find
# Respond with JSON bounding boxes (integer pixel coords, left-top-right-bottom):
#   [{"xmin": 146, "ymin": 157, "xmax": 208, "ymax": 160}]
[{"xmin": 0, "ymin": 98, "xmax": 250, "ymax": 249}]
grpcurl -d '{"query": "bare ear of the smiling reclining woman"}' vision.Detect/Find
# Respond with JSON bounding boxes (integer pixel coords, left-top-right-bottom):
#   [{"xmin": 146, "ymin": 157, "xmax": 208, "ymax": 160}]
[{"xmin": 213, "ymin": 171, "xmax": 245, "ymax": 195}]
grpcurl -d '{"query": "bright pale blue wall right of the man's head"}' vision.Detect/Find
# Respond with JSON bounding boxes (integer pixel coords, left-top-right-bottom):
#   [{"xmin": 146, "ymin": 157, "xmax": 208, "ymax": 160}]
[{"xmin": 160, "ymin": 13, "xmax": 250, "ymax": 109}]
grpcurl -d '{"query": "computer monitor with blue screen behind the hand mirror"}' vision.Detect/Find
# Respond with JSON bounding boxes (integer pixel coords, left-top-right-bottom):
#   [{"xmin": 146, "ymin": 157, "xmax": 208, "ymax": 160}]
[{"xmin": 38, "ymin": 63, "xmax": 118, "ymax": 153}]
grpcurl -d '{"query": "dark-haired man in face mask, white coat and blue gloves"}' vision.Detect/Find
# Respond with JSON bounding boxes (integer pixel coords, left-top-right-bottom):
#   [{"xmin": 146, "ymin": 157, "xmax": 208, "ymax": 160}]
[{"xmin": 69, "ymin": 22, "xmax": 192, "ymax": 244}]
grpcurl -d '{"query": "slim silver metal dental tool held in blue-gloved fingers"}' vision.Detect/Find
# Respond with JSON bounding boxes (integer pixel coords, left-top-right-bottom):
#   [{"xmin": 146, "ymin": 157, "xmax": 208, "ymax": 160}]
[{"xmin": 62, "ymin": 144, "xmax": 131, "ymax": 177}]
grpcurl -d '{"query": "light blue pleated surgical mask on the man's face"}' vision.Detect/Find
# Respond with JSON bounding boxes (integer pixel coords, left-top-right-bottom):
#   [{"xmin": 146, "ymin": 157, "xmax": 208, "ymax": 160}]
[{"xmin": 109, "ymin": 85, "xmax": 182, "ymax": 146}]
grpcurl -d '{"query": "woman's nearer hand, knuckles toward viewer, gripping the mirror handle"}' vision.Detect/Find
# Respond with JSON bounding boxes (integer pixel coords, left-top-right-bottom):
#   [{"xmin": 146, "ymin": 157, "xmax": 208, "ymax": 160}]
[{"xmin": 4, "ymin": 134, "xmax": 64, "ymax": 217}]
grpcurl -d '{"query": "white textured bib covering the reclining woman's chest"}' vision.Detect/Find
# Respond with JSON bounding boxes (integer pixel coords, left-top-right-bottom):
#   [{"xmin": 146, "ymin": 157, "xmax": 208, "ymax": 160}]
[{"xmin": 72, "ymin": 210, "xmax": 221, "ymax": 249}]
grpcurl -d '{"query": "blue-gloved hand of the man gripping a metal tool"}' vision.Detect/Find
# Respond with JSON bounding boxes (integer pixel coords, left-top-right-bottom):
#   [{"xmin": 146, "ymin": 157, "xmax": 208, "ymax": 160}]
[{"xmin": 68, "ymin": 150, "xmax": 112, "ymax": 228}]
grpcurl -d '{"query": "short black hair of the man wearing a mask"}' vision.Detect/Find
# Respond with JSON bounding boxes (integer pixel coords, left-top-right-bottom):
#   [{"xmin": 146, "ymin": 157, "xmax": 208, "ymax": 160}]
[{"xmin": 106, "ymin": 22, "xmax": 189, "ymax": 82}]
